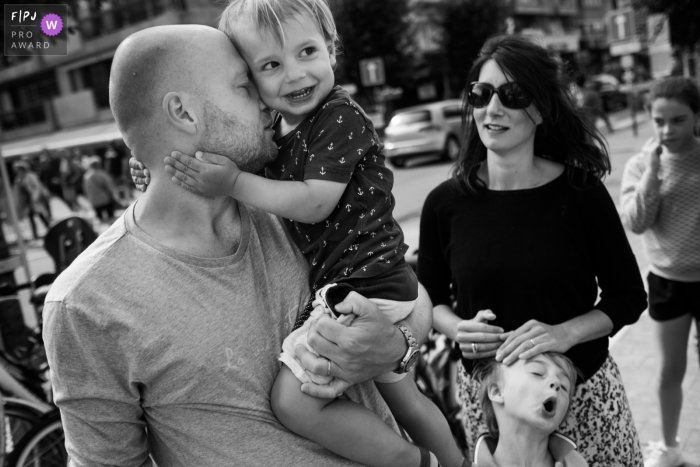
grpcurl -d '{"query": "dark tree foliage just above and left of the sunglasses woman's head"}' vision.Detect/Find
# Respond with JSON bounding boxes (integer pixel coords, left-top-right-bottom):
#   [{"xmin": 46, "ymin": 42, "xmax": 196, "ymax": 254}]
[{"xmin": 442, "ymin": 0, "xmax": 508, "ymax": 98}]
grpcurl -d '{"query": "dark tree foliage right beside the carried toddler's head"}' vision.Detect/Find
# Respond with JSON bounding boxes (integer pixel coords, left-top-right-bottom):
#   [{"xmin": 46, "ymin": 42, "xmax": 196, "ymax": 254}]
[{"xmin": 330, "ymin": 0, "xmax": 410, "ymax": 95}]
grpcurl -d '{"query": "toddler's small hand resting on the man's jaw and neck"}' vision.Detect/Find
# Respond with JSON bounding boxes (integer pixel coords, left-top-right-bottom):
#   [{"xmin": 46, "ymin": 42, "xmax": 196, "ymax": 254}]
[{"xmin": 165, "ymin": 151, "xmax": 241, "ymax": 197}]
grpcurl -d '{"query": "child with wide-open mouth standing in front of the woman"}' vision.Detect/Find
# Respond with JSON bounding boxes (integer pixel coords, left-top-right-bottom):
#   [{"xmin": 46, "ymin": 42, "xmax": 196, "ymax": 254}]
[{"xmin": 472, "ymin": 352, "xmax": 588, "ymax": 467}]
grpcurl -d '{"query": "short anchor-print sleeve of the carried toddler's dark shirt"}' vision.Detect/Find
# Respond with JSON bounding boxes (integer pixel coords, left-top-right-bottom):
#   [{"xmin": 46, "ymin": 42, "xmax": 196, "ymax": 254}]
[{"xmin": 304, "ymin": 102, "xmax": 379, "ymax": 183}]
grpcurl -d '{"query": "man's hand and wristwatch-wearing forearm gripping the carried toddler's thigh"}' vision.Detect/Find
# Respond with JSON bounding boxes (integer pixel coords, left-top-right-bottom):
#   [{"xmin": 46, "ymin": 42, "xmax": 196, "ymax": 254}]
[{"xmin": 297, "ymin": 285, "xmax": 433, "ymax": 398}]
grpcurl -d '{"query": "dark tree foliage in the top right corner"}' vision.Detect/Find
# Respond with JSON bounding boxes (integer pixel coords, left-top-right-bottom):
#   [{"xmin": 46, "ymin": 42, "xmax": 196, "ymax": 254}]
[{"xmin": 633, "ymin": 0, "xmax": 700, "ymax": 49}]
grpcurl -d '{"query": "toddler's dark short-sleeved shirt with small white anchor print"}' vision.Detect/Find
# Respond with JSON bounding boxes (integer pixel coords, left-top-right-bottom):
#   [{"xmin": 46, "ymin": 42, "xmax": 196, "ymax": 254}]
[{"xmin": 266, "ymin": 87, "xmax": 408, "ymax": 290}]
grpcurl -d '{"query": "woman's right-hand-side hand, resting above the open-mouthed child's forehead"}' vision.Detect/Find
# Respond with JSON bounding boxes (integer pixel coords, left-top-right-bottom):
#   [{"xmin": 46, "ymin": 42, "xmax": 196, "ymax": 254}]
[{"xmin": 496, "ymin": 319, "xmax": 574, "ymax": 365}]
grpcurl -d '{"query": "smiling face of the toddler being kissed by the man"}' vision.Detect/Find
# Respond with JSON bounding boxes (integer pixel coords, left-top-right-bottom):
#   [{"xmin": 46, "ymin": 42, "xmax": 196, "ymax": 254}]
[{"xmin": 236, "ymin": 14, "xmax": 335, "ymax": 130}]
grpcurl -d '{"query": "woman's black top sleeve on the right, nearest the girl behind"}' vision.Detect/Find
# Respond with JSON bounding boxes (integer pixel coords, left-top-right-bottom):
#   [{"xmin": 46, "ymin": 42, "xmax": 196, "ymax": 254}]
[{"xmin": 585, "ymin": 183, "xmax": 647, "ymax": 335}]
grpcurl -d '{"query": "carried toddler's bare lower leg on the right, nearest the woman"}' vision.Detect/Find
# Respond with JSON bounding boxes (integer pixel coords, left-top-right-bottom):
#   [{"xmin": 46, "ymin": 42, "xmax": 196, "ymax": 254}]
[{"xmin": 376, "ymin": 375, "xmax": 464, "ymax": 467}]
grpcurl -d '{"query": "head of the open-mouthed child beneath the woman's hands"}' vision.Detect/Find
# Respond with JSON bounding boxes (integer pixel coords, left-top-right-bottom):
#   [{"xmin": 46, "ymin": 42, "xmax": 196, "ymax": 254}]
[{"xmin": 474, "ymin": 352, "xmax": 579, "ymax": 438}]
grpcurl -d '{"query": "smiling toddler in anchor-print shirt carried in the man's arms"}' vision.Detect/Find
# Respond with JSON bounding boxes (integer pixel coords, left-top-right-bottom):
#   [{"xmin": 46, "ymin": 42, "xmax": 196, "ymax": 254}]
[{"xmin": 137, "ymin": 0, "xmax": 464, "ymax": 466}]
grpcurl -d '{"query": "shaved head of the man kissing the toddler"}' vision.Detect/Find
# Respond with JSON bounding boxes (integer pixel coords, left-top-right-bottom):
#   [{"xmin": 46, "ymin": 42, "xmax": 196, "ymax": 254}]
[{"xmin": 109, "ymin": 25, "xmax": 276, "ymax": 181}]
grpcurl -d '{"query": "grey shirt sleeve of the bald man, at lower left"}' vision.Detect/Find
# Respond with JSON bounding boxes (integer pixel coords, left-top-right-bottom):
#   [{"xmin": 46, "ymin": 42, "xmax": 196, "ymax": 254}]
[{"xmin": 43, "ymin": 301, "xmax": 152, "ymax": 467}]
